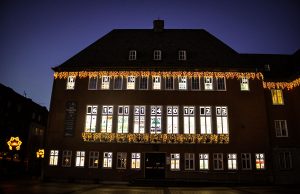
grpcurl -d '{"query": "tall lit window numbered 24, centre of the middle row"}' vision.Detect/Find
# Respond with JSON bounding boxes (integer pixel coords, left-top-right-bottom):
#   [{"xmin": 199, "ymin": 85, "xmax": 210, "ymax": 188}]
[{"xmin": 150, "ymin": 106, "xmax": 162, "ymax": 134}]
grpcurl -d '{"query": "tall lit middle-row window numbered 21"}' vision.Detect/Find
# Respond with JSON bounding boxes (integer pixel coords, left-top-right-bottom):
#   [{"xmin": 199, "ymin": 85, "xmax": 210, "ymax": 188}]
[{"xmin": 133, "ymin": 106, "xmax": 146, "ymax": 133}]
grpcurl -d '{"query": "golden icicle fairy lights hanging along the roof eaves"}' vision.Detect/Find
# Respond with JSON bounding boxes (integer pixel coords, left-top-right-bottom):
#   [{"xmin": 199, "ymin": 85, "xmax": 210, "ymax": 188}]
[{"xmin": 54, "ymin": 71, "xmax": 300, "ymax": 90}]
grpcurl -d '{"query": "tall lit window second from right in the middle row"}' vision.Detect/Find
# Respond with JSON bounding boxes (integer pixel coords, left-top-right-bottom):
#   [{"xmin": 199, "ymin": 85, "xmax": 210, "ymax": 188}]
[{"xmin": 200, "ymin": 106, "xmax": 212, "ymax": 134}]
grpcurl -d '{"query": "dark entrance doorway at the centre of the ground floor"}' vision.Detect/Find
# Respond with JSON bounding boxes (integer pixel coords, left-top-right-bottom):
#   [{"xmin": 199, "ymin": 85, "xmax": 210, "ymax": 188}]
[{"xmin": 145, "ymin": 153, "xmax": 166, "ymax": 179}]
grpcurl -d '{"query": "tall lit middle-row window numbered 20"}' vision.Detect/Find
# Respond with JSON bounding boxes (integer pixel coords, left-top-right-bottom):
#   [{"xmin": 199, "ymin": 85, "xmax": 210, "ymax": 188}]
[{"xmin": 167, "ymin": 106, "xmax": 178, "ymax": 134}]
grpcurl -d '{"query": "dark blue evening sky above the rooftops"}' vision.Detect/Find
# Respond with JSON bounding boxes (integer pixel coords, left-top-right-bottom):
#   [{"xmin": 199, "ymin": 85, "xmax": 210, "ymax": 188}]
[{"xmin": 0, "ymin": 0, "xmax": 300, "ymax": 107}]
